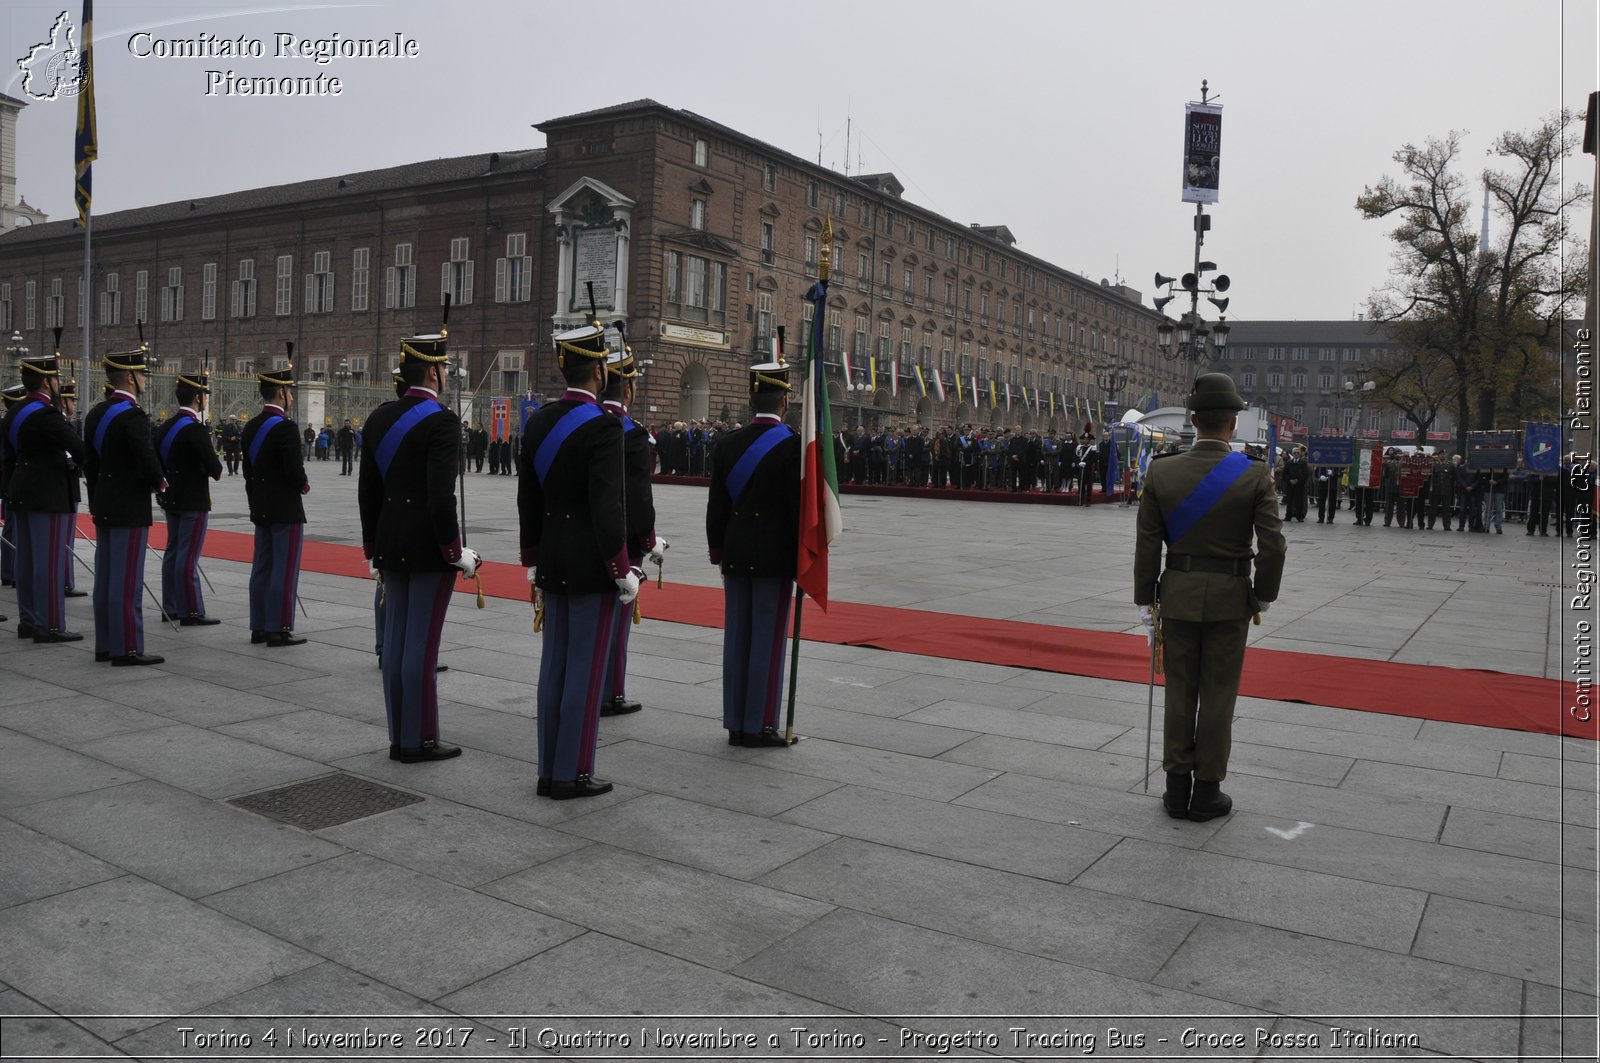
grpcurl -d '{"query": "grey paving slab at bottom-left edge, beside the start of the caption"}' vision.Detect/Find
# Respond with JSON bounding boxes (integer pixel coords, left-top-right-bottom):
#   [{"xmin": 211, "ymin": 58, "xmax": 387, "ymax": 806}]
[{"xmin": 0, "ymin": 876, "xmax": 318, "ymax": 1041}]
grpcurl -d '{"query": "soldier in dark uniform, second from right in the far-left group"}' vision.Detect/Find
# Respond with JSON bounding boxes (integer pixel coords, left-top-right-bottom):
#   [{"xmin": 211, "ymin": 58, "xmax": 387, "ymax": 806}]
[{"xmin": 154, "ymin": 373, "xmax": 222, "ymax": 628}]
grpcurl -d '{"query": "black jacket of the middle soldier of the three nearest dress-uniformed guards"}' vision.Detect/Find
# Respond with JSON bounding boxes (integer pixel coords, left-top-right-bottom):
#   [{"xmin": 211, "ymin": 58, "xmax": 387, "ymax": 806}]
[{"xmin": 517, "ymin": 391, "xmax": 629, "ymax": 594}]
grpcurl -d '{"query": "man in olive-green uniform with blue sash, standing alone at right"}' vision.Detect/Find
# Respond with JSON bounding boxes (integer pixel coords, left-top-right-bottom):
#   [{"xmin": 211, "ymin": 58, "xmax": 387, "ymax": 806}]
[{"xmin": 1133, "ymin": 373, "xmax": 1286, "ymax": 821}]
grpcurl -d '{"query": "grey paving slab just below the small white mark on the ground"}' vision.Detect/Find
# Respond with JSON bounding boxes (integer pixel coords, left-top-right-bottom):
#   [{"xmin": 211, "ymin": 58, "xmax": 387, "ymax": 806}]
[{"xmin": 1072, "ymin": 837, "xmax": 1427, "ymax": 953}]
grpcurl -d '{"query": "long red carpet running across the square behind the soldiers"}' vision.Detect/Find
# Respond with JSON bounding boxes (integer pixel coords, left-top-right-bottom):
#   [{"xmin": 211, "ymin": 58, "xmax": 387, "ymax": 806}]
[{"xmin": 128, "ymin": 517, "xmax": 1600, "ymax": 740}]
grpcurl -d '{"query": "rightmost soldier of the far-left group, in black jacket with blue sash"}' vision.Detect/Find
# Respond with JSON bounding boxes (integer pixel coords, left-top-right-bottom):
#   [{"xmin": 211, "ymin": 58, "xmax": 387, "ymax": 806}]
[{"xmin": 240, "ymin": 352, "xmax": 310, "ymax": 647}]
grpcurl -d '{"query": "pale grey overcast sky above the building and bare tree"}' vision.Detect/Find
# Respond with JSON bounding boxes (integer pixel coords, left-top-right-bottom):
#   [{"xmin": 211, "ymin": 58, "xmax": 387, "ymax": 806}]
[{"xmin": 0, "ymin": 0, "xmax": 1600, "ymax": 320}]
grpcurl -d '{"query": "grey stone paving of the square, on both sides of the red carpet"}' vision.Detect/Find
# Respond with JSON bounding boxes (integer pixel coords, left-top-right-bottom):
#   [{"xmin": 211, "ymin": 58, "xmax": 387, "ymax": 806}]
[{"xmin": 0, "ymin": 463, "xmax": 1597, "ymax": 1060}]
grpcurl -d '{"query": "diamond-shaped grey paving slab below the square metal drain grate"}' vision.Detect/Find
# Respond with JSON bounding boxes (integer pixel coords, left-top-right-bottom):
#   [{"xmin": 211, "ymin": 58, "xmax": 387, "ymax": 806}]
[{"xmin": 205, "ymin": 853, "xmax": 581, "ymax": 1001}]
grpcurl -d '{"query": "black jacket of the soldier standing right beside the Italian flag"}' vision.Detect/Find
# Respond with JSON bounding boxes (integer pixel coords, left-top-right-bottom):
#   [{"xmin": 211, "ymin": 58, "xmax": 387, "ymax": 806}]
[{"xmin": 706, "ymin": 421, "xmax": 800, "ymax": 580}]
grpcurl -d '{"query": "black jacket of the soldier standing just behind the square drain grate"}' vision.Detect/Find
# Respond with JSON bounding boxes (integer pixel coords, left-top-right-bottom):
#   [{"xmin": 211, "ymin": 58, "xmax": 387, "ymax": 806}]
[{"xmin": 357, "ymin": 389, "xmax": 461, "ymax": 572}]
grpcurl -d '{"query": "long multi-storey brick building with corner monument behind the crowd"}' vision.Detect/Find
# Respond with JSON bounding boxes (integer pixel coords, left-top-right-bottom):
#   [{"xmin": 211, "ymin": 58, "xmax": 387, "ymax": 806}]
[{"xmin": 0, "ymin": 99, "xmax": 1187, "ymax": 427}]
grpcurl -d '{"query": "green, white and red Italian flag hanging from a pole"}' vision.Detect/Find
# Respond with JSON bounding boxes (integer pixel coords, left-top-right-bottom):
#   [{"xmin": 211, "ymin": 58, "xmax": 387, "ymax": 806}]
[{"xmin": 795, "ymin": 280, "xmax": 845, "ymax": 612}]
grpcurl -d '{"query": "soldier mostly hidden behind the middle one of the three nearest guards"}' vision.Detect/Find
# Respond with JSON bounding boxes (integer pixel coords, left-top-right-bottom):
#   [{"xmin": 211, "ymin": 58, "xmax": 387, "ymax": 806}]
[{"xmin": 600, "ymin": 344, "xmax": 667, "ymax": 716}]
